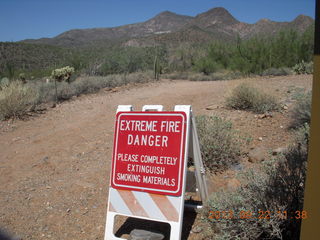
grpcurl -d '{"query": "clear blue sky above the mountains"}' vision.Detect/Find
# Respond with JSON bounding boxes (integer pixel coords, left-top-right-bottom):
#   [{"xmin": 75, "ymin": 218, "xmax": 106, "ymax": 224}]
[{"xmin": 0, "ymin": 0, "xmax": 315, "ymax": 42}]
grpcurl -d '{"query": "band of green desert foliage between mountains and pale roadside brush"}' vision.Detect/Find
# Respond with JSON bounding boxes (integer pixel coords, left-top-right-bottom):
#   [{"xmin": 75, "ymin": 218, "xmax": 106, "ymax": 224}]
[{"xmin": 0, "ymin": 25, "xmax": 314, "ymax": 79}]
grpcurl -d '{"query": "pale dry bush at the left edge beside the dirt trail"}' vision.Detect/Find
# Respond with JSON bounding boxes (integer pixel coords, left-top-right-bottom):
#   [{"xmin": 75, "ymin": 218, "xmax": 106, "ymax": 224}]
[{"xmin": 0, "ymin": 81, "xmax": 37, "ymax": 119}]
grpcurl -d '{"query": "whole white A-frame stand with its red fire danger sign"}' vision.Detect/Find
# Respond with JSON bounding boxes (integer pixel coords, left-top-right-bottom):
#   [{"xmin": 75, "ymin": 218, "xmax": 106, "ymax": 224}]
[{"xmin": 105, "ymin": 105, "xmax": 208, "ymax": 240}]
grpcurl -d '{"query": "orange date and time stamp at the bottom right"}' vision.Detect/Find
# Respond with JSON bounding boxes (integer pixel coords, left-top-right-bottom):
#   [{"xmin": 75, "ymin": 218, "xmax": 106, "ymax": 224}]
[{"xmin": 208, "ymin": 210, "xmax": 308, "ymax": 220}]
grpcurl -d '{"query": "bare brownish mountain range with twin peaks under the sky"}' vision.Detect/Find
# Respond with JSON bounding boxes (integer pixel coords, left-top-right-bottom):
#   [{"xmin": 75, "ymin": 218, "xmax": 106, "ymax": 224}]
[{"xmin": 23, "ymin": 7, "xmax": 314, "ymax": 47}]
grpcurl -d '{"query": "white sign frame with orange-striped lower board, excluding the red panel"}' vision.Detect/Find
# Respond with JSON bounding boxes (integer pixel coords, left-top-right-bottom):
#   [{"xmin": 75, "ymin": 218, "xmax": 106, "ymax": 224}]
[{"xmin": 104, "ymin": 105, "xmax": 208, "ymax": 240}]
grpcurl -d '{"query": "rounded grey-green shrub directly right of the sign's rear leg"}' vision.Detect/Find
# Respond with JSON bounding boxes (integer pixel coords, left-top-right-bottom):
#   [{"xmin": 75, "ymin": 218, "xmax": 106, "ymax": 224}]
[{"xmin": 196, "ymin": 115, "xmax": 243, "ymax": 172}]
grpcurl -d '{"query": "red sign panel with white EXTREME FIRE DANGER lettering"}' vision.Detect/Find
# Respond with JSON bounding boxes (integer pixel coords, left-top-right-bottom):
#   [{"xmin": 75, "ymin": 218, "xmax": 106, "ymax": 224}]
[{"xmin": 111, "ymin": 112, "xmax": 186, "ymax": 195}]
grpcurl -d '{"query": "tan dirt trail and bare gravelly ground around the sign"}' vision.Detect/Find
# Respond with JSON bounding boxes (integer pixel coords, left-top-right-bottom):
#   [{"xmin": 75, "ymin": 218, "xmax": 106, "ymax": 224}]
[{"xmin": 0, "ymin": 75, "xmax": 312, "ymax": 240}]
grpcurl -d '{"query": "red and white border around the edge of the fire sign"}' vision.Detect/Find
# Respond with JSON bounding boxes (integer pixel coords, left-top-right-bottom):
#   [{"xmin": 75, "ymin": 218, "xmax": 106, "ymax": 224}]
[{"xmin": 110, "ymin": 111, "xmax": 187, "ymax": 196}]
